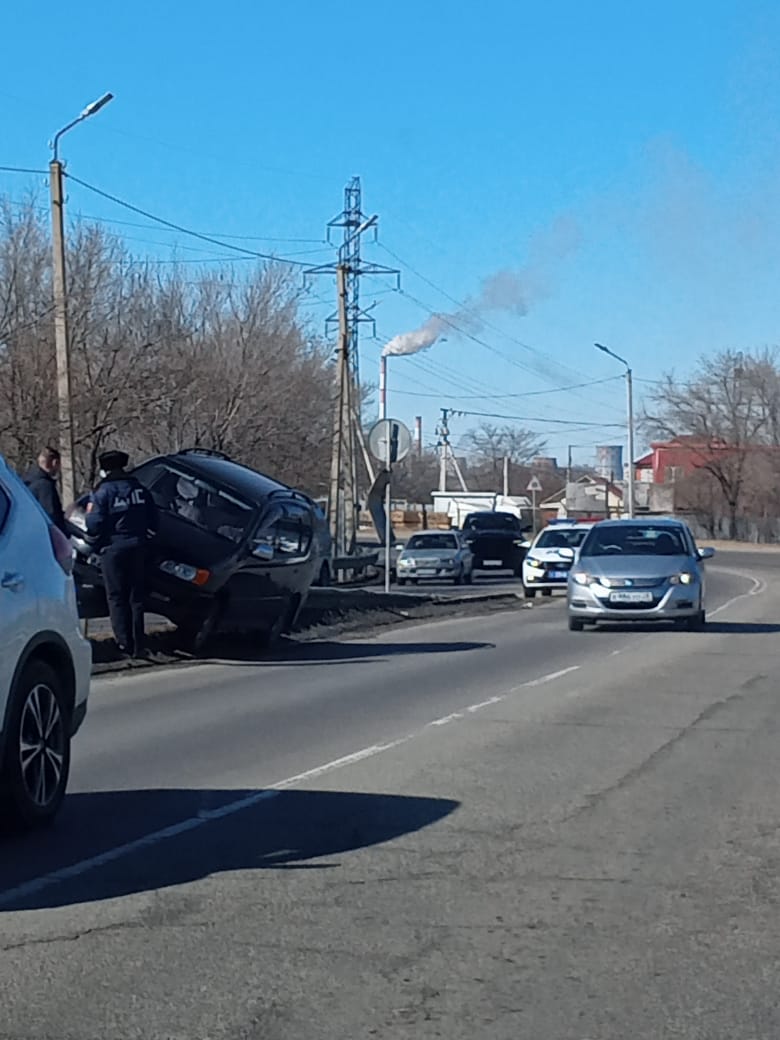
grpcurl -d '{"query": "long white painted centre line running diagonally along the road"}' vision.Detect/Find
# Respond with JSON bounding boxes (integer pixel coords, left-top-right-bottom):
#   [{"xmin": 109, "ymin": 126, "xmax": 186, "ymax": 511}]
[{"xmin": 0, "ymin": 665, "xmax": 580, "ymax": 906}]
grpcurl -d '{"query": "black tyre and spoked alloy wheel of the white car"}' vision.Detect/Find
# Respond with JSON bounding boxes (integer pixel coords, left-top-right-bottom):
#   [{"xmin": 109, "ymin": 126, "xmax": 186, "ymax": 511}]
[{"xmin": 0, "ymin": 661, "xmax": 71, "ymax": 828}]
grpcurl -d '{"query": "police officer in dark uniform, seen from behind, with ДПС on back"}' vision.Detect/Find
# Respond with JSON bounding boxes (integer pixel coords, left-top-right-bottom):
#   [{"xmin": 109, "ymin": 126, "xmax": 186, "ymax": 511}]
[{"xmin": 86, "ymin": 451, "xmax": 157, "ymax": 657}]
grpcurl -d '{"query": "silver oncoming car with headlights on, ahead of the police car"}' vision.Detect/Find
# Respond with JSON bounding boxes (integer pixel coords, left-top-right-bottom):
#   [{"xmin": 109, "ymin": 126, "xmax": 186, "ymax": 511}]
[{"xmin": 567, "ymin": 519, "xmax": 714, "ymax": 632}]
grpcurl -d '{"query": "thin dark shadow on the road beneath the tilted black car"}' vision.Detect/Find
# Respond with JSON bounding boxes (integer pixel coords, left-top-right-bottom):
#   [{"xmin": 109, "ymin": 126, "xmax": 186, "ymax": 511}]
[{"xmin": 208, "ymin": 639, "xmax": 495, "ymax": 665}]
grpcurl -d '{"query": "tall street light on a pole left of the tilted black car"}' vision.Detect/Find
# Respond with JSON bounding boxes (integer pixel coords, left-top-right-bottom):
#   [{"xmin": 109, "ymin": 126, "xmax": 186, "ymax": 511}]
[{"xmin": 49, "ymin": 94, "xmax": 113, "ymax": 505}]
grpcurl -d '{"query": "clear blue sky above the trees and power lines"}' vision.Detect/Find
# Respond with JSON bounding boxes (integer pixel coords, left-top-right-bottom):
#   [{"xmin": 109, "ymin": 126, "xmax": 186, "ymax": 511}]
[{"xmin": 0, "ymin": 0, "xmax": 780, "ymax": 460}]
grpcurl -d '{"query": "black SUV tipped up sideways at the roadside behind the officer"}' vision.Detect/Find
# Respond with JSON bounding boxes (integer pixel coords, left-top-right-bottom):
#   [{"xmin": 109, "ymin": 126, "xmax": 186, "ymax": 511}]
[{"xmin": 68, "ymin": 448, "xmax": 329, "ymax": 649}]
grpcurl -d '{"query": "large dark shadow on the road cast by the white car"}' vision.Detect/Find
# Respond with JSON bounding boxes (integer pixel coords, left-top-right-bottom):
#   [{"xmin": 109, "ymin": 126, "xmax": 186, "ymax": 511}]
[{"xmin": 0, "ymin": 790, "xmax": 460, "ymax": 919}]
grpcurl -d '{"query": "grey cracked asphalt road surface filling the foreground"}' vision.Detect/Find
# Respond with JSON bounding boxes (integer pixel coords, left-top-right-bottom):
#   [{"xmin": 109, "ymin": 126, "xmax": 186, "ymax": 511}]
[{"xmin": 0, "ymin": 554, "xmax": 780, "ymax": 1040}]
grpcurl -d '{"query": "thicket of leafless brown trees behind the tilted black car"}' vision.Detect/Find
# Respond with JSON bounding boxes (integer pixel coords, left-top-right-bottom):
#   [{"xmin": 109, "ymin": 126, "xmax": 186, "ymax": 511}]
[{"xmin": 0, "ymin": 200, "xmax": 333, "ymax": 503}]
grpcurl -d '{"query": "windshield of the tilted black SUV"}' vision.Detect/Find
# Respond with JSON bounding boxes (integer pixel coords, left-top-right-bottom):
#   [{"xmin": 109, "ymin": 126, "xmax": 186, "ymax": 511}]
[{"xmin": 133, "ymin": 462, "xmax": 254, "ymax": 542}]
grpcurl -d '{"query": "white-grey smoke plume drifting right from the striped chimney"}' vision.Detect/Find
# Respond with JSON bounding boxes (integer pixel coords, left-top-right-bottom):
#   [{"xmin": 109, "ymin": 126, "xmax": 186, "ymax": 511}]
[{"xmin": 382, "ymin": 217, "xmax": 579, "ymax": 357}]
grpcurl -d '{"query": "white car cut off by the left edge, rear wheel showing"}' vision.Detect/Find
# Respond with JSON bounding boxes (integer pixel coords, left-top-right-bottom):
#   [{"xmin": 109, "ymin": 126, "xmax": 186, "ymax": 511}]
[{"xmin": 0, "ymin": 457, "xmax": 92, "ymax": 827}]
